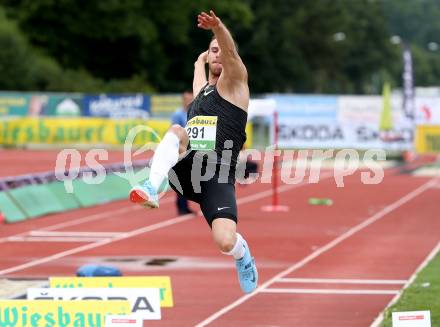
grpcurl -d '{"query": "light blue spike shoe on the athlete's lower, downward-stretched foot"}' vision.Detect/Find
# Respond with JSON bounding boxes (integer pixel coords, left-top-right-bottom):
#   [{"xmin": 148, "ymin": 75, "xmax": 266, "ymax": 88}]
[{"xmin": 235, "ymin": 240, "xmax": 258, "ymax": 293}]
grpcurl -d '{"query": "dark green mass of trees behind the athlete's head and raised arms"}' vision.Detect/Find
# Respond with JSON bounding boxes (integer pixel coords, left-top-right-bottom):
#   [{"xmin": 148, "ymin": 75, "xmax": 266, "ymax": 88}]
[{"xmin": 0, "ymin": 0, "xmax": 440, "ymax": 94}]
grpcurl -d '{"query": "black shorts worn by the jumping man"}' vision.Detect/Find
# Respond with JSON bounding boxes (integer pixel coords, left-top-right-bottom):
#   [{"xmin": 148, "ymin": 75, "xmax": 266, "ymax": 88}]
[{"xmin": 168, "ymin": 151, "xmax": 237, "ymax": 226}]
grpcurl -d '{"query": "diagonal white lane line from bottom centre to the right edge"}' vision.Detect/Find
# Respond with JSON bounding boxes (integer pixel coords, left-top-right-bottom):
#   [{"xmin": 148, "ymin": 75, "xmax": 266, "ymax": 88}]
[{"xmin": 195, "ymin": 179, "xmax": 434, "ymax": 327}]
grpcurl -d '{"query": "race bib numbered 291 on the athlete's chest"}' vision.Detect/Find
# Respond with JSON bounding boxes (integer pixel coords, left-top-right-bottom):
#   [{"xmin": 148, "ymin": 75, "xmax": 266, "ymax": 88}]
[{"xmin": 186, "ymin": 116, "xmax": 217, "ymax": 151}]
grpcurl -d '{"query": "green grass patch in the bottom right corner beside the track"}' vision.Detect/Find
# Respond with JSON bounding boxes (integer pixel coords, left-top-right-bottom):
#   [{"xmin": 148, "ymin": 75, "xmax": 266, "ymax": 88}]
[{"xmin": 381, "ymin": 253, "xmax": 440, "ymax": 327}]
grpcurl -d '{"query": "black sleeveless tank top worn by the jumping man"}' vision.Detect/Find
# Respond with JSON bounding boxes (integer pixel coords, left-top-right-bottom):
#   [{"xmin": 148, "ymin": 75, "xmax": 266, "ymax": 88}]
[{"xmin": 187, "ymin": 84, "xmax": 247, "ymax": 170}]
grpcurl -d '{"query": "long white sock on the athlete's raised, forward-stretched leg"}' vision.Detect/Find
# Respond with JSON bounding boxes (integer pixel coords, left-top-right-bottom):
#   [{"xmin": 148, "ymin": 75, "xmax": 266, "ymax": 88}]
[{"xmin": 148, "ymin": 132, "xmax": 180, "ymax": 190}]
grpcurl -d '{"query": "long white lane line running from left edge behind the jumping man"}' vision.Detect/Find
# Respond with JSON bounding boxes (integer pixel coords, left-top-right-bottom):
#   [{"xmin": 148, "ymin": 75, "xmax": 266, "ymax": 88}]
[{"xmin": 0, "ymin": 174, "xmax": 332, "ymax": 275}]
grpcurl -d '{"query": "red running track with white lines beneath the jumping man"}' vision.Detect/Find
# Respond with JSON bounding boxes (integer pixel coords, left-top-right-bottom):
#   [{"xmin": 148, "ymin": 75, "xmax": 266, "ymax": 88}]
[{"xmin": 0, "ymin": 161, "xmax": 440, "ymax": 326}]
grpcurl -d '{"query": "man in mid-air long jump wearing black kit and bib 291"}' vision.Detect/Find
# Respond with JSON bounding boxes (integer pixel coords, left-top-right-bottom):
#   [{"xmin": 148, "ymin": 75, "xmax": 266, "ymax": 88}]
[{"xmin": 130, "ymin": 10, "xmax": 258, "ymax": 293}]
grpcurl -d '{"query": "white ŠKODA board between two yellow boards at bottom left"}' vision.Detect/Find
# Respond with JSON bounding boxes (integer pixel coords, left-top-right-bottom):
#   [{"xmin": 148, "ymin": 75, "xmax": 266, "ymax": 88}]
[{"xmin": 27, "ymin": 288, "xmax": 161, "ymax": 320}]
